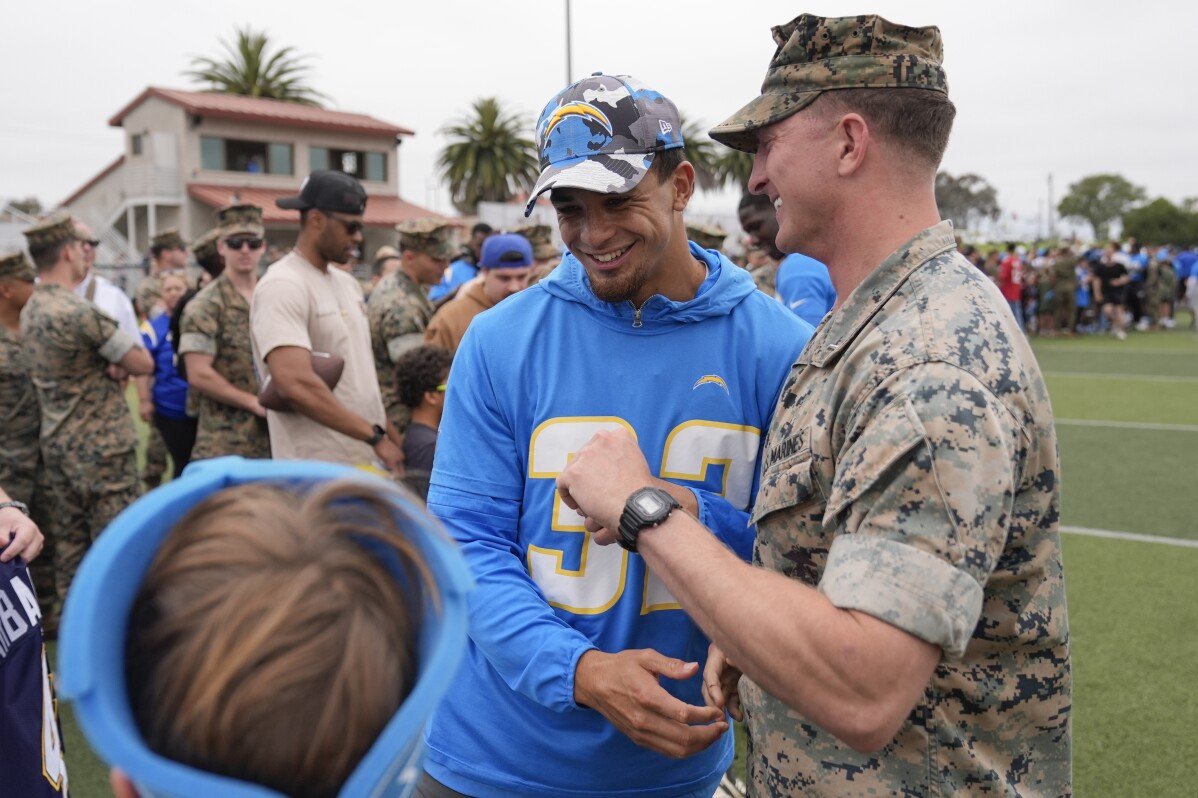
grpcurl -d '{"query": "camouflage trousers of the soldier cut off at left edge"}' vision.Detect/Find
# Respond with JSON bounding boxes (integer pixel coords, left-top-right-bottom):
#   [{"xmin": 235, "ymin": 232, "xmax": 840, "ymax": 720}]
[{"xmin": 0, "ymin": 437, "xmax": 61, "ymax": 634}]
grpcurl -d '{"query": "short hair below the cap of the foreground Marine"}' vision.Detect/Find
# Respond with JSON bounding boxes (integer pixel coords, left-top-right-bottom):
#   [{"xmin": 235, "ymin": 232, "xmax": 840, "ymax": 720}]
[{"xmin": 811, "ymin": 89, "xmax": 957, "ymax": 171}]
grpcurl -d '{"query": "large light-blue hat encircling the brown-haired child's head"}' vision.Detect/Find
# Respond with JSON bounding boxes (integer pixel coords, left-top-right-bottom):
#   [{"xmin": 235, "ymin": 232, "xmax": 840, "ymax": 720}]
[{"xmin": 59, "ymin": 457, "xmax": 473, "ymax": 798}]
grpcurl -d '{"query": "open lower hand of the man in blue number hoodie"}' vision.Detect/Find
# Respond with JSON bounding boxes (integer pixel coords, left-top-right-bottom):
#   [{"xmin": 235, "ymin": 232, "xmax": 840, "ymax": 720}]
[{"xmin": 574, "ymin": 648, "xmax": 728, "ymax": 758}]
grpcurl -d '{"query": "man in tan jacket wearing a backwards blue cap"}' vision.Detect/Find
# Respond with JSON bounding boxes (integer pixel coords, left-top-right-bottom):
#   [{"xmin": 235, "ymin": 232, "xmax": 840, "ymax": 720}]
[{"xmin": 424, "ymin": 232, "xmax": 533, "ymax": 352}]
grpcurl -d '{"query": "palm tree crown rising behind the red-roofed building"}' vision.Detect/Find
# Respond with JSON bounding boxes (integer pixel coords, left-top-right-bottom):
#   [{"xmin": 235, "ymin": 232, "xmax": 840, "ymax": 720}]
[{"xmin": 183, "ymin": 26, "xmax": 327, "ymax": 107}]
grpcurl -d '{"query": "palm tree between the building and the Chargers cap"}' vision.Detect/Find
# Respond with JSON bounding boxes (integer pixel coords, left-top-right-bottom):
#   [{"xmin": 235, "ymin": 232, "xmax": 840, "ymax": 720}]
[{"xmin": 437, "ymin": 97, "xmax": 540, "ymax": 213}]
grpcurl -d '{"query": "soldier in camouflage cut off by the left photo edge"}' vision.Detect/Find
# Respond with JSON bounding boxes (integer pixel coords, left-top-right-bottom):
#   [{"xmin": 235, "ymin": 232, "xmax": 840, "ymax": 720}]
[{"xmin": 0, "ymin": 253, "xmax": 59, "ymax": 613}]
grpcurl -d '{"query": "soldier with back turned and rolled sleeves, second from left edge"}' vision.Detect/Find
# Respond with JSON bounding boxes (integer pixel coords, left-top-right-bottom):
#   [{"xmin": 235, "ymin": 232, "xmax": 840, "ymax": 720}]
[{"xmin": 20, "ymin": 213, "xmax": 153, "ymax": 600}]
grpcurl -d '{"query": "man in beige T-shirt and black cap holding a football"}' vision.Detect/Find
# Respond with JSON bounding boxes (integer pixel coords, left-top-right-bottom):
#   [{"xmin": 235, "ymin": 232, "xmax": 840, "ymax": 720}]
[{"xmin": 249, "ymin": 171, "xmax": 404, "ymax": 472}]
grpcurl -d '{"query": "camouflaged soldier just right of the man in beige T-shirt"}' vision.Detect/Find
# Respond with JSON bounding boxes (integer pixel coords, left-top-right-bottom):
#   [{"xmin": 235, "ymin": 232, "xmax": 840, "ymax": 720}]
[{"xmin": 367, "ymin": 219, "xmax": 453, "ymax": 434}]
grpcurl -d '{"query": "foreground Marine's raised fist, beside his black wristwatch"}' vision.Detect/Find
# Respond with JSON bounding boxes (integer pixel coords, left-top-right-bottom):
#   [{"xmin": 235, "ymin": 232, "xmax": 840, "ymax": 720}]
[{"xmin": 557, "ymin": 429, "xmax": 657, "ymax": 534}]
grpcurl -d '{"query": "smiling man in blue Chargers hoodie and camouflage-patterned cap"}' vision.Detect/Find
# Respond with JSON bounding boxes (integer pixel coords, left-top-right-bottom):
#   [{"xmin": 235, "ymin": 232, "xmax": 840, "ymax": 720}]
[{"xmin": 418, "ymin": 74, "xmax": 812, "ymax": 798}]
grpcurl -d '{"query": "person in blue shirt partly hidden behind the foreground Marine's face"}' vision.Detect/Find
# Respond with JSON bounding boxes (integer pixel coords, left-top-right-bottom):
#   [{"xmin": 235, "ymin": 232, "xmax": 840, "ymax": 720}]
[{"xmin": 737, "ymin": 193, "xmax": 836, "ymax": 327}]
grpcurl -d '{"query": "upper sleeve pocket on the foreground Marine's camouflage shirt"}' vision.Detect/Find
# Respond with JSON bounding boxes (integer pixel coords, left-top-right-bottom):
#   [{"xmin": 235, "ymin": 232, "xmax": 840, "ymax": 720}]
[{"xmin": 823, "ymin": 397, "xmax": 926, "ymax": 528}]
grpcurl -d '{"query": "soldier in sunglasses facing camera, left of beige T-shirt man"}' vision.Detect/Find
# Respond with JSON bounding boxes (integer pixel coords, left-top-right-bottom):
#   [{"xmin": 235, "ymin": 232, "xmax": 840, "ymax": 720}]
[{"xmin": 177, "ymin": 205, "xmax": 271, "ymax": 460}]
